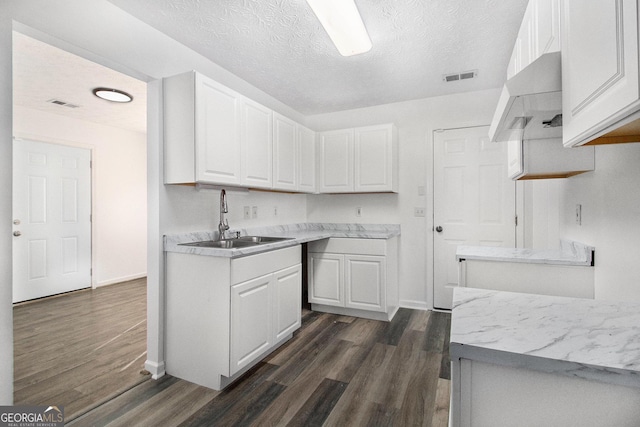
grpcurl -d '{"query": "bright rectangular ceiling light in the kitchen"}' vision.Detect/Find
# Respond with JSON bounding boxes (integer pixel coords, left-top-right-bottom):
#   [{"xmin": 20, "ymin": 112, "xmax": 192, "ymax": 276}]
[{"xmin": 307, "ymin": 0, "xmax": 372, "ymax": 56}]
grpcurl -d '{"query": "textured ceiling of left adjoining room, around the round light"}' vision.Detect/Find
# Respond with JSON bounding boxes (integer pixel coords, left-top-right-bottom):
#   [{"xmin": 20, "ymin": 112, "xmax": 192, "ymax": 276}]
[{"xmin": 13, "ymin": 31, "xmax": 147, "ymax": 132}]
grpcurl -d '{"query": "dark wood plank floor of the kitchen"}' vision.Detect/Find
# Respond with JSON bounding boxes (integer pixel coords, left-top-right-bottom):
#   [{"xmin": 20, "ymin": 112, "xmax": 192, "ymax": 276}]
[{"xmin": 69, "ymin": 309, "xmax": 451, "ymax": 427}]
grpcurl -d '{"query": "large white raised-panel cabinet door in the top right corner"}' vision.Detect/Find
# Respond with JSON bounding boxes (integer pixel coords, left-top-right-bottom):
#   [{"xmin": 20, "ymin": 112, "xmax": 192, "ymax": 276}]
[{"xmin": 562, "ymin": 0, "xmax": 638, "ymax": 146}]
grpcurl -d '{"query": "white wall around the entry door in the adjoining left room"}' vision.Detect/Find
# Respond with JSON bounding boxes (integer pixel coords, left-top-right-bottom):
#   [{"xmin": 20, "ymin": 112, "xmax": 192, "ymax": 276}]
[{"xmin": 13, "ymin": 106, "xmax": 147, "ymax": 286}]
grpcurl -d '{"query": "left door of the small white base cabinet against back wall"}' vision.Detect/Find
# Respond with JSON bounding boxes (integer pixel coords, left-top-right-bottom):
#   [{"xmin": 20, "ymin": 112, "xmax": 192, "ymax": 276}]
[{"xmin": 307, "ymin": 253, "xmax": 344, "ymax": 307}]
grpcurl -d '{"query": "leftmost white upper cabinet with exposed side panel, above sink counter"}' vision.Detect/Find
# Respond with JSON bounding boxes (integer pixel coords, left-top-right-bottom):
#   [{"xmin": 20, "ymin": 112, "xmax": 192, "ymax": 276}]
[{"xmin": 163, "ymin": 72, "xmax": 241, "ymax": 185}]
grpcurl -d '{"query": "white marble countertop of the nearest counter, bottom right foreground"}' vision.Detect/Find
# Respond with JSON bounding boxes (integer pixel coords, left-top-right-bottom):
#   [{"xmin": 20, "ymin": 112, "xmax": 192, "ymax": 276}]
[{"xmin": 450, "ymin": 288, "xmax": 640, "ymax": 388}]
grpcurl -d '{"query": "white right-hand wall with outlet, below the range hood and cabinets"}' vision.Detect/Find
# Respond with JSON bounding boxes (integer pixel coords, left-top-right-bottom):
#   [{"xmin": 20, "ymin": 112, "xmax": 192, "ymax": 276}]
[{"xmin": 559, "ymin": 143, "xmax": 640, "ymax": 301}]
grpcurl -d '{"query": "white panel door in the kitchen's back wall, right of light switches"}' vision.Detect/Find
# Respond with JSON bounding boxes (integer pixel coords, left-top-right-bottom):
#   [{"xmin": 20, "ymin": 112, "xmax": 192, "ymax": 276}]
[{"xmin": 433, "ymin": 126, "xmax": 516, "ymax": 309}]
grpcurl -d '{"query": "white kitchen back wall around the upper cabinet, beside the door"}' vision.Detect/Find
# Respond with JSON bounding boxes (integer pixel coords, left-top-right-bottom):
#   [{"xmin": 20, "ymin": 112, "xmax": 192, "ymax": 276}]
[{"xmin": 307, "ymin": 89, "xmax": 500, "ymax": 309}]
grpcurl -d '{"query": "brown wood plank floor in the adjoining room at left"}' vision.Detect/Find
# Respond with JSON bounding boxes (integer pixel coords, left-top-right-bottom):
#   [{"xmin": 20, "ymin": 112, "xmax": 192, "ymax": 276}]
[{"xmin": 13, "ymin": 279, "xmax": 149, "ymax": 420}]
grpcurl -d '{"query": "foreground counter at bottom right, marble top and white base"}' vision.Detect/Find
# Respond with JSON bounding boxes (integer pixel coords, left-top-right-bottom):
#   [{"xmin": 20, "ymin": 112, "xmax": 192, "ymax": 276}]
[{"xmin": 450, "ymin": 288, "xmax": 640, "ymax": 426}]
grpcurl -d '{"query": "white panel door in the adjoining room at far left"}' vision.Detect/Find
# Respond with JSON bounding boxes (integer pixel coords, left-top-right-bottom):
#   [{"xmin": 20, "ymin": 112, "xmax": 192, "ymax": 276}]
[{"xmin": 13, "ymin": 140, "xmax": 91, "ymax": 302}]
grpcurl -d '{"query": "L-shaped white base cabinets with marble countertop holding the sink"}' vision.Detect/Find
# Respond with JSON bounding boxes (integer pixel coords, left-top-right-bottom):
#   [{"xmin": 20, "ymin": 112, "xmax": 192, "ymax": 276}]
[{"xmin": 164, "ymin": 223, "xmax": 400, "ymax": 390}]
